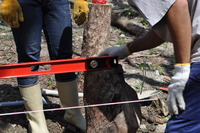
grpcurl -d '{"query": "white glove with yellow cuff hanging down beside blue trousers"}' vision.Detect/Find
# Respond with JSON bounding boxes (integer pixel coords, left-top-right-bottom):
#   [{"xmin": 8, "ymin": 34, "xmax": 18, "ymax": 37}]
[{"xmin": 167, "ymin": 63, "xmax": 190, "ymax": 115}]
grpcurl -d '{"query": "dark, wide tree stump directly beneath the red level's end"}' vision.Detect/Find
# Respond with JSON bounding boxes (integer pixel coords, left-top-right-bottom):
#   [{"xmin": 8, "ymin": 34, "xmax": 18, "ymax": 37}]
[{"xmin": 84, "ymin": 65, "xmax": 141, "ymax": 133}]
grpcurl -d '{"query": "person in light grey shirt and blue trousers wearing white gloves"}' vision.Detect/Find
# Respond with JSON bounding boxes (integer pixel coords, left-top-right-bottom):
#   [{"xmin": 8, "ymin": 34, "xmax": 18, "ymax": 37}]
[{"xmin": 99, "ymin": 0, "xmax": 200, "ymax": 133}]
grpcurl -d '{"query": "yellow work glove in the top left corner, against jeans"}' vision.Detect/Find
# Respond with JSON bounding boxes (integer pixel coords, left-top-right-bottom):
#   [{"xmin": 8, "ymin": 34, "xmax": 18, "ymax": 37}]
[{"xmin": 0, "ymin": 0, "xmax": 24, "ymax": 28}]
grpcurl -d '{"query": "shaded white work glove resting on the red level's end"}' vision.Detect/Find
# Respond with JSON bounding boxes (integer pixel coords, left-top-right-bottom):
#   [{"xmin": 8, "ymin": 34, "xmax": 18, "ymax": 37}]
[{"xmin": 99, "ymin": 45, "xmax": 131, "ymax": 59}]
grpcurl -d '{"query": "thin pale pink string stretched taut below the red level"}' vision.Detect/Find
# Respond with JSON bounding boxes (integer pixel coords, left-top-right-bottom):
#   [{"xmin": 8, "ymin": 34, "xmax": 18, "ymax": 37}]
[{"xmin": 0, "ymin": 98, "xmax": 158, "ymax": 116}]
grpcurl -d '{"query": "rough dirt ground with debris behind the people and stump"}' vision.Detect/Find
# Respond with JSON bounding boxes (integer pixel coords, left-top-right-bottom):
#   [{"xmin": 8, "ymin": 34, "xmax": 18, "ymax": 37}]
[{"xmin": 0, "ymin": 1, "xmax": 174, "ymax": 133}]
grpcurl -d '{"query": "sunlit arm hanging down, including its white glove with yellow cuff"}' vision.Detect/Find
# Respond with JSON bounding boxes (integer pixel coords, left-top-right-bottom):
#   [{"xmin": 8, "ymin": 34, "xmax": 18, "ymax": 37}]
[{"xmin": 166, "ymin": 0, "xmax": 192, "ymax": 115}]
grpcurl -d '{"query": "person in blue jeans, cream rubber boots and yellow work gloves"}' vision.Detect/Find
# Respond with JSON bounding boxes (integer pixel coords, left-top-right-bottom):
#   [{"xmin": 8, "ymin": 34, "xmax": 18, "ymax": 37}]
[{"xmin": 0, "ymin": 0, "xmax": 89, "ymax": 133}]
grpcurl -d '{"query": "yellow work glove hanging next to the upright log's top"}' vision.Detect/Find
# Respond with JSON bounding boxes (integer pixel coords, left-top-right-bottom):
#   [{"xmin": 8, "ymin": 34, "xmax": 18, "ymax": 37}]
[{"xmin": 73, "ymin": 0, "xmax": 89, "ymax": 25}]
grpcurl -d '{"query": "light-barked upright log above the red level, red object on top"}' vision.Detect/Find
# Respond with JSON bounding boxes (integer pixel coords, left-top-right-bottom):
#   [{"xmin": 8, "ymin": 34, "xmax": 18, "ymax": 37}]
[{"xmin": 82, "ymin": 4, "xmax": 112, "ymax": 57}]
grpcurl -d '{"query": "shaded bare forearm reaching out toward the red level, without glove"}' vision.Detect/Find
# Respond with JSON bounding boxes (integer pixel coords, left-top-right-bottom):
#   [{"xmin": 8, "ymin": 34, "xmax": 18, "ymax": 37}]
[{"xmin": 127, "ymin": 30, "xmax": 164, "ymax": 53}]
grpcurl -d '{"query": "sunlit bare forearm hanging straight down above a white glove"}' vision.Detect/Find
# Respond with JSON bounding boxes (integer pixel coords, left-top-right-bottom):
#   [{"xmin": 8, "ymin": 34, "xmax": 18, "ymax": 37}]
[{"xmin": 167, "ymin": 0, "xmax": 192, "ymax": 63}]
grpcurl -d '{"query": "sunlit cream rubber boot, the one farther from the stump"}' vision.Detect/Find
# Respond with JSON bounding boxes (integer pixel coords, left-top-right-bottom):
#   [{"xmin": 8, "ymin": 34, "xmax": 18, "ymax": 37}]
[{"xmin": 19, "ymin": 83, "xmax": 49, "ymax": 133}]
